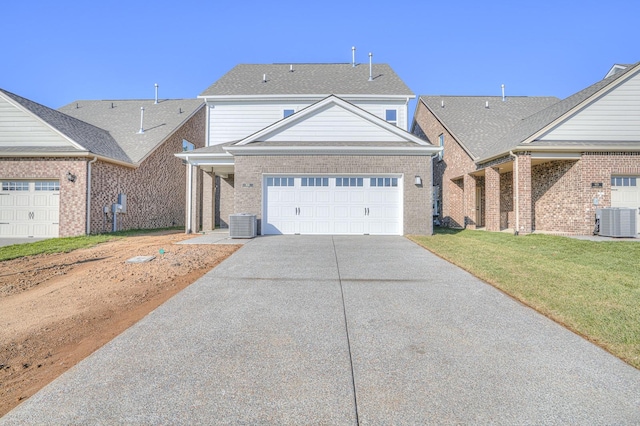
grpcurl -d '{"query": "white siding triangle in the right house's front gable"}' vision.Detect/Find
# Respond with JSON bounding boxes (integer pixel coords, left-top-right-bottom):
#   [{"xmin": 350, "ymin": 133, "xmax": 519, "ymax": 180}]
[{"xmin": 540, "ymin": 72, "xmax": 640, "ymax": 142}]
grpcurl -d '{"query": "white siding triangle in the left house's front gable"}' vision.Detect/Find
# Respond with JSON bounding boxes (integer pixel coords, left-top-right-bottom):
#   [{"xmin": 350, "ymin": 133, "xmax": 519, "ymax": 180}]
[{"xmin": 0, "ymin": 95, "xmax": 73, "ymax": 148}]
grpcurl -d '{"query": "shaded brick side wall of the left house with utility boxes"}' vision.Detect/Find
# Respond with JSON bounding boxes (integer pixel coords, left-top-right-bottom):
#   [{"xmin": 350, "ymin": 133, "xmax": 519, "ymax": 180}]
[{"xmin": 91, "ymin": 108, "xmax": 205, "ymax": 233}]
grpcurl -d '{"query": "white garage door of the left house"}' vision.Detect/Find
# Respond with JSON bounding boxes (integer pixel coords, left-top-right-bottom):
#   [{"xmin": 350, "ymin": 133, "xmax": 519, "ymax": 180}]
[{"xmin": 0, "ymin": 180, "xmax": 60, "ymax": 238}]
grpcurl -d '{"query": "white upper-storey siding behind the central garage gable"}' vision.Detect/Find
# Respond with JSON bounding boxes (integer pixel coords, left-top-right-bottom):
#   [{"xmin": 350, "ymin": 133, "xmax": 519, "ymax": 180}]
[{"xmin": 208, "ymin": 98, "xmax": 407, "ymax": 145}]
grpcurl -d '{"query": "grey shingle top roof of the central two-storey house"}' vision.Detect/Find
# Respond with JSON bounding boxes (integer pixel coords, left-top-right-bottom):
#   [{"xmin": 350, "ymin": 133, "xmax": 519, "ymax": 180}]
[{"xmin": 200, "ymin": 64, "xmax": 414, "ymax": 96}]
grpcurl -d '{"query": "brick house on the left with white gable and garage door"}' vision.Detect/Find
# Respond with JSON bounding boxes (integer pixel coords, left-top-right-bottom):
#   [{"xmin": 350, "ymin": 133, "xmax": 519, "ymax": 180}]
[{"xmin": 0, "ymin": 90, "xmax": 205, "ymax": 237}]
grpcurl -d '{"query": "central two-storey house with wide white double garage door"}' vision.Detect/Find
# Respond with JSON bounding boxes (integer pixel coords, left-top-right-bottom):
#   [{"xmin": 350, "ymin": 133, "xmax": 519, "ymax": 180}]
[{"xmin": 177, "ymin": 63, "xmax": 439, "ymax": 235}]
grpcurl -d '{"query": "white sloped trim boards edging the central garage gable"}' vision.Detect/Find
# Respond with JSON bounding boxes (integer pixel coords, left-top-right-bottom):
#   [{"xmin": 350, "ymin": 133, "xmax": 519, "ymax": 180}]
[{"xmin": 235, "ymin": 95, "xmax": 432, "ymax": 149}]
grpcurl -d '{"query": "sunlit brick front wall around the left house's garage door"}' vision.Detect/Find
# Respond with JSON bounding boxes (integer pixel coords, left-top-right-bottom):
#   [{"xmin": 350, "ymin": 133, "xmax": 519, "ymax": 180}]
[{"xmin": 0, "ymin": 158, "xmax": 87, "ymax": 237}]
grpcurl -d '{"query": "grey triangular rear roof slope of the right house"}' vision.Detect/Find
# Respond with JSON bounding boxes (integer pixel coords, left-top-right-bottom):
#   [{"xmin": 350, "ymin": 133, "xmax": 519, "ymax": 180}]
[{"xmin": 420, "ymin": 96, "xmax": 559, "ymax": 159}]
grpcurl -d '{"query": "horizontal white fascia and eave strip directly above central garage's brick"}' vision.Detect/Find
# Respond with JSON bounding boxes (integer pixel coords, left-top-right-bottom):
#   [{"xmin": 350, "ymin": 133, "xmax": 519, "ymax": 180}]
[{"xmin": 224, "ymin": 145, "xmax": 442, "ymax": 156}]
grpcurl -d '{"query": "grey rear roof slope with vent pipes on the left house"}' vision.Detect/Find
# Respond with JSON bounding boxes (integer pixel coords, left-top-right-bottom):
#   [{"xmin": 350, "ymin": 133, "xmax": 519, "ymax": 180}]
[{"xmin": 59, "ymin": 99, "xmax": 203, "ymax": 163}]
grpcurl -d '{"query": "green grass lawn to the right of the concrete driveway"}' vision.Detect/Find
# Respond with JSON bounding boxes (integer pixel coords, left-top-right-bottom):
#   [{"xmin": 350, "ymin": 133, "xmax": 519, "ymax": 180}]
[{"xmin": 412, "ymin": 229, "xmax": 640, "ymax": 368}]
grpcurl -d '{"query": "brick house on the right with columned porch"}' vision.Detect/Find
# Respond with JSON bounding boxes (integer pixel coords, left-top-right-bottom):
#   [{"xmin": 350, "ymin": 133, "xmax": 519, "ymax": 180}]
[{"xmin": 411, "ymin": 63, "xmax": 640, "ymax": 234}]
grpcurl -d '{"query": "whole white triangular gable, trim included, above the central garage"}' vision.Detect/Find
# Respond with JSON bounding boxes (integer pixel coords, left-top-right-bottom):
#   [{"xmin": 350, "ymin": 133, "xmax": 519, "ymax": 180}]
[{"xmin": 236, "ymin": 96, "xmax": 430, "ymax": 146}]
